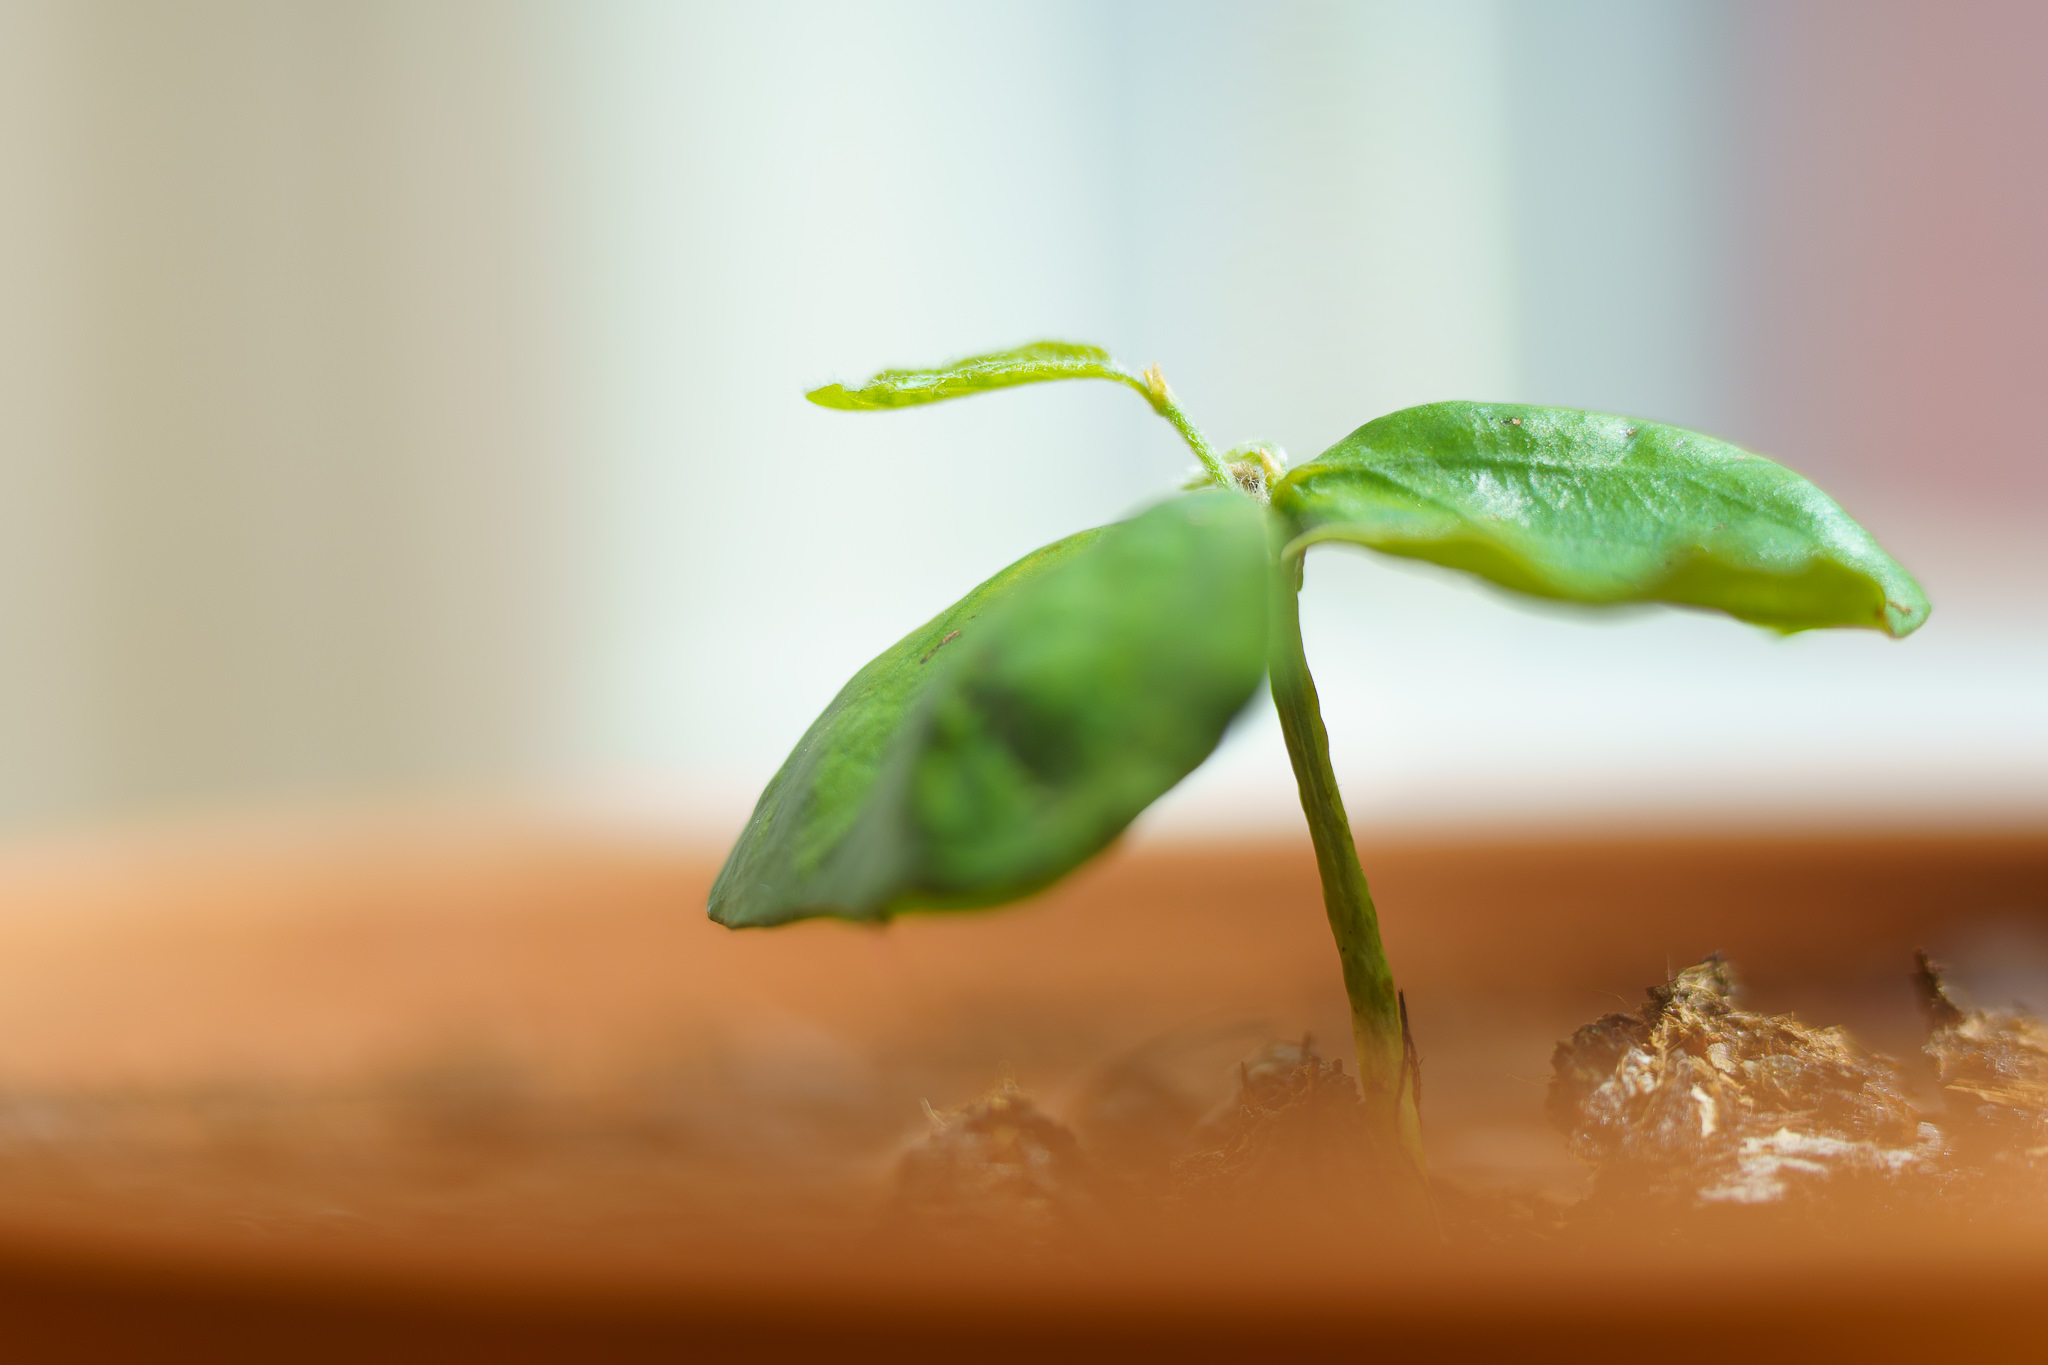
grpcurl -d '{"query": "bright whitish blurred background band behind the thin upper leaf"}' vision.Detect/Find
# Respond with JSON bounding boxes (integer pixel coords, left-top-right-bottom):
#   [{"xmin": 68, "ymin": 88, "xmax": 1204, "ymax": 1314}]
[{"xmin": 552, "ymin": 4, "xmax": 1516, "ymax": 834}]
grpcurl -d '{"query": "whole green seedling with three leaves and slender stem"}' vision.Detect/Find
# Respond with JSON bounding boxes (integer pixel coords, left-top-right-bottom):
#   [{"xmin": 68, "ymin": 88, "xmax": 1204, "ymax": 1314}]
[{"xmin": 711, "ymin": 342, "xmax": 1927, "ymax": 1179}]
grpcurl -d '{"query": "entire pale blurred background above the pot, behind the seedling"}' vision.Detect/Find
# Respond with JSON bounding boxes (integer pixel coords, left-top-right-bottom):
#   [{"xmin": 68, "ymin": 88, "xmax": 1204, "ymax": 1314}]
[{"xmin": 0, "ymin": 0, "xmax": 2048, "ymax": 845}]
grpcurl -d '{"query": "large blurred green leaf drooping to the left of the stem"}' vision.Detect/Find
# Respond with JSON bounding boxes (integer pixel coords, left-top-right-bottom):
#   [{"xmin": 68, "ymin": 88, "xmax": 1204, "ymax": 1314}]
[{"xmin": 711, "ymin": 491, "xmax": 1268, "ymax": 927}]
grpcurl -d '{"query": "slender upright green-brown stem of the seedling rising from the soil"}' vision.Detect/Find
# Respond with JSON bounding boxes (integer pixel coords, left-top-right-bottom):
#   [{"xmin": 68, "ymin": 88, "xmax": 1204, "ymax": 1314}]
[{"xmin": 1266, "ymin": 546, "xmax": 1427, "ymax": 1181}]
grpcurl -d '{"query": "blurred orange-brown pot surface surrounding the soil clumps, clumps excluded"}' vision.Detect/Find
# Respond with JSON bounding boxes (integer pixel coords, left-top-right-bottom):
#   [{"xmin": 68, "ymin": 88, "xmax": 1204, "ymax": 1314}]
[{"xmin": 0, "ymin": 823, "xmax": 2048, "ymax": 1359}]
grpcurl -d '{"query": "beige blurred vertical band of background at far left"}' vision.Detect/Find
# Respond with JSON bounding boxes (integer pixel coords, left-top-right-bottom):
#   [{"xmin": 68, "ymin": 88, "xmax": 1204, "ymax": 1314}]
[{"xmin": 0, "ymin": 0, "xmax": 586, "ymax": 823}]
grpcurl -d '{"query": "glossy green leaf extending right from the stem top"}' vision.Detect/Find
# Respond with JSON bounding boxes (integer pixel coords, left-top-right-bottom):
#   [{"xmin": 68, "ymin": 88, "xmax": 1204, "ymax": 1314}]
[{"xmin": 1272, "ymin": 403, "xmax": 1927, "ymax": 636}]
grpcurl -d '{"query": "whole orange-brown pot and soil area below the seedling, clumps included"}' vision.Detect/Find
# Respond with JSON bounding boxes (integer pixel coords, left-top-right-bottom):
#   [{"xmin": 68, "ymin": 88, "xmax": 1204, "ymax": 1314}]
[{"xmin": 0, "ymin": 827, "xmax": 2048, "ymax": 1359}]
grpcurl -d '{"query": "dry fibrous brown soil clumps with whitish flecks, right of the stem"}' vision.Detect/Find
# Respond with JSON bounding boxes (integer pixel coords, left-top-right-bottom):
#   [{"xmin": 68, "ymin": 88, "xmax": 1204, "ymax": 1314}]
[{"xmin": 1548, "ymin": 954, "xmax": 2048, "ymax": 1222}]
